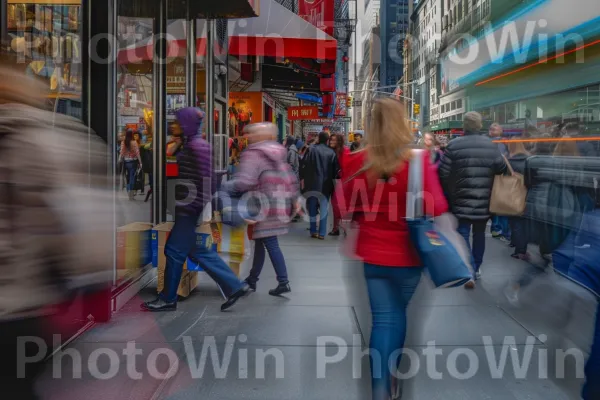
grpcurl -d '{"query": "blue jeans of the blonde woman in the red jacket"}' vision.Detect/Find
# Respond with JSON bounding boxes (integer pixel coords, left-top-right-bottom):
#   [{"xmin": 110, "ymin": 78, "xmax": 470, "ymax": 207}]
[{"xmin": 364, "ymin": 263, "xmax": 423, "ymax": 400}]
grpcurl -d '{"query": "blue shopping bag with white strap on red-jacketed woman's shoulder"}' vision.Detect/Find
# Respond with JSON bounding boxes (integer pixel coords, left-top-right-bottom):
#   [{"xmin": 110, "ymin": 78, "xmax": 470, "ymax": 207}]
[{"xmin": 406, "ymin": 150, "xmax": 473, "ymax": 288}]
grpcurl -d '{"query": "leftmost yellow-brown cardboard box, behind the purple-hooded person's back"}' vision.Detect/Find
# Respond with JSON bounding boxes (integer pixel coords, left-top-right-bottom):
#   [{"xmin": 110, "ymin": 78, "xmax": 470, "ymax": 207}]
[{"xmin": 117, "ymin": 222, "xmax": 152, "ymax": 272}]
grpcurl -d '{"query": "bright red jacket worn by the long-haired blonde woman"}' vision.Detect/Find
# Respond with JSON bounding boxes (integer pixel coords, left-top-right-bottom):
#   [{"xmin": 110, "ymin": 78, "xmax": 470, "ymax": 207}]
[{"xmin": 338, "ymin": 151, "xmax": 448, "ymax": 267}]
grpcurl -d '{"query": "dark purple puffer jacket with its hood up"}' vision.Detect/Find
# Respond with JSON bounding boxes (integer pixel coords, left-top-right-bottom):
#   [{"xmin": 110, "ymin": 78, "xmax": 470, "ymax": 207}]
[{"xmin": 175, "ymin": 107, "xmax": 217, "ymax": 215}]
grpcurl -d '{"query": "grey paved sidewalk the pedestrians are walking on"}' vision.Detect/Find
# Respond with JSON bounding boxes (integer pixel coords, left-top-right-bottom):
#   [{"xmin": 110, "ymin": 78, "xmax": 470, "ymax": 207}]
[{"xmin": 40, "ymin": 224, "xmax": 582, "ymax": 400}]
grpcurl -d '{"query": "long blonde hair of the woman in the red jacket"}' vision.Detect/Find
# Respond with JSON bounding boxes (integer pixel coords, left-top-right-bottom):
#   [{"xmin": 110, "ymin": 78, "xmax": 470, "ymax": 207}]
[{"xmin": 366, "ymin": 99, "xmax": 414, "ymax": 177}]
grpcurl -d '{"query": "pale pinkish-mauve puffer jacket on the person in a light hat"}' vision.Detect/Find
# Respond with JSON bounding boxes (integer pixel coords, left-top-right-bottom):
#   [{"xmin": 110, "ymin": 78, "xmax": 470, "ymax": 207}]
[{"xmin": 232, "ymin": 141, "xmax": 298, "ymax": 239}]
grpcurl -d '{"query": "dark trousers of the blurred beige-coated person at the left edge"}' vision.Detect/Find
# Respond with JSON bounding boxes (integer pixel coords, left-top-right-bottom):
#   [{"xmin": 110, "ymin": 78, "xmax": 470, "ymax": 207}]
[{"xmin": 0, "ymin": 318, "xmax": 50, "ymax": 400}]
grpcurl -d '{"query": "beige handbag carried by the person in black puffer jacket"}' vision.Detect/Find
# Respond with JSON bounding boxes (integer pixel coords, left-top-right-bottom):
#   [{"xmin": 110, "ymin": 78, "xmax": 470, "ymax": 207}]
[{"xmin": 490, "ymin": 156, "xmax": 527, "ymax": 217}]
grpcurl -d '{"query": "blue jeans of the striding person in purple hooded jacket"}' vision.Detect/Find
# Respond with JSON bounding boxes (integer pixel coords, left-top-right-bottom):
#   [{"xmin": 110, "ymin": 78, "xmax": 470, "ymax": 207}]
[{"xmin": 160, "ymin": 215, "xmax": 243, "ymax": 303}]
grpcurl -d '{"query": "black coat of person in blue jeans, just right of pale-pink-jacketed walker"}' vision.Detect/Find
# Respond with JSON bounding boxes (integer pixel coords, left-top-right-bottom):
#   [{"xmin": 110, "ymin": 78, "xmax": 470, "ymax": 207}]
[{"xmin": 300, "ymin": 144, "xmax": 340, "ymax": 197}]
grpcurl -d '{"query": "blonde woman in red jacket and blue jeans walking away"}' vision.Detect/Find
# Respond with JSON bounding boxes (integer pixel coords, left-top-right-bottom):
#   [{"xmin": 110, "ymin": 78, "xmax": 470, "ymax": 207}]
[{"xmin": 343, "ymin": 99, "xmax": 448, "ymax": 400}]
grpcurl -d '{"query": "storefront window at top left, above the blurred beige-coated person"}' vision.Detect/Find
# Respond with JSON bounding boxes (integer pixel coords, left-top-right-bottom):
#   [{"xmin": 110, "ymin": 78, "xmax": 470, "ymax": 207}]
[{"xmin": 1, "ymin": 0, "xmax": 82, "ymax": 119}]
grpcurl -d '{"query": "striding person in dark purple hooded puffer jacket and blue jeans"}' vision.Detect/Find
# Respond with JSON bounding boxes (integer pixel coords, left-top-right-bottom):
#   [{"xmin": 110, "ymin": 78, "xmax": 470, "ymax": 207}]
[{"xmin": 142, "ymin": 107, "xmax": 248, "ymax": 311}]
